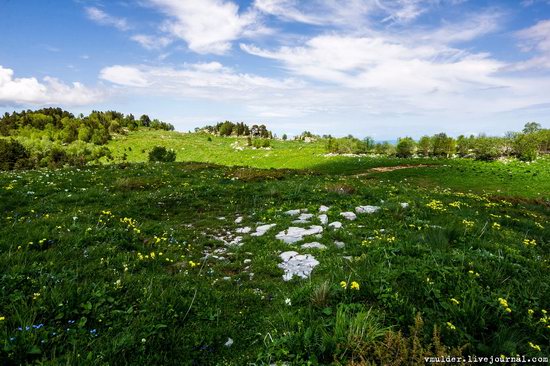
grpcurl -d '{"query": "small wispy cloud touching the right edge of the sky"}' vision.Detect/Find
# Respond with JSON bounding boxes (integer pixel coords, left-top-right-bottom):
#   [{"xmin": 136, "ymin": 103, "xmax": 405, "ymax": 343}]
[{"xmin": 515, "ymin": 19, "xmax": 550, "ymax": 70}]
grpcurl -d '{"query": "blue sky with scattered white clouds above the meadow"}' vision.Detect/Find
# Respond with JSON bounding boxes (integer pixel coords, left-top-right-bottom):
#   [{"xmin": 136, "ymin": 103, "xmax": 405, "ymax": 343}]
[{"xmin": 0, "ymin": 0, "xmax": 550, "ymax": 140}]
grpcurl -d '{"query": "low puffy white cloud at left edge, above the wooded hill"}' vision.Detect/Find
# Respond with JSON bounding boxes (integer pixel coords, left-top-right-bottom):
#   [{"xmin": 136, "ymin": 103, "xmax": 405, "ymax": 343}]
[{"xmin": 0, "ymin": 66, "xmax": 101, "ymax": 105}]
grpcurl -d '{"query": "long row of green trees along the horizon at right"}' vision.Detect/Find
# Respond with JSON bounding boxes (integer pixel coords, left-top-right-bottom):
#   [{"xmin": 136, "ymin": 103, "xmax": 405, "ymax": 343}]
[{"xmin": 325, "ymin": 122, "xmax": 550, "ymax": 161}]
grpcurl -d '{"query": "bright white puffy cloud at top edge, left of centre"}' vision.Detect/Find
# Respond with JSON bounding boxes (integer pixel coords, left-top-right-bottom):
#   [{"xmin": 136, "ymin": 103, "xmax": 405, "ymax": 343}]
[{"xmin": 149, "ymin": 0, "xmax": 265, "ymax": 54}]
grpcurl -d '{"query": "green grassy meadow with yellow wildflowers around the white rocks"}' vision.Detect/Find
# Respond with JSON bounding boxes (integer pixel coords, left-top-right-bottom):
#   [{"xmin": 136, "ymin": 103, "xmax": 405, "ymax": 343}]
[{"xmin": 0, "ymin": 131, "xmax": 550, "ymax": 365}]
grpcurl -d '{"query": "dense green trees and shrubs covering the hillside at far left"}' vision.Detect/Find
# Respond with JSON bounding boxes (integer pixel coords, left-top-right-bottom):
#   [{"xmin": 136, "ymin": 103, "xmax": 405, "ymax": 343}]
[{"xmin": 0, "ymin": 108, "xmax": 174, "ymax": 170}]
